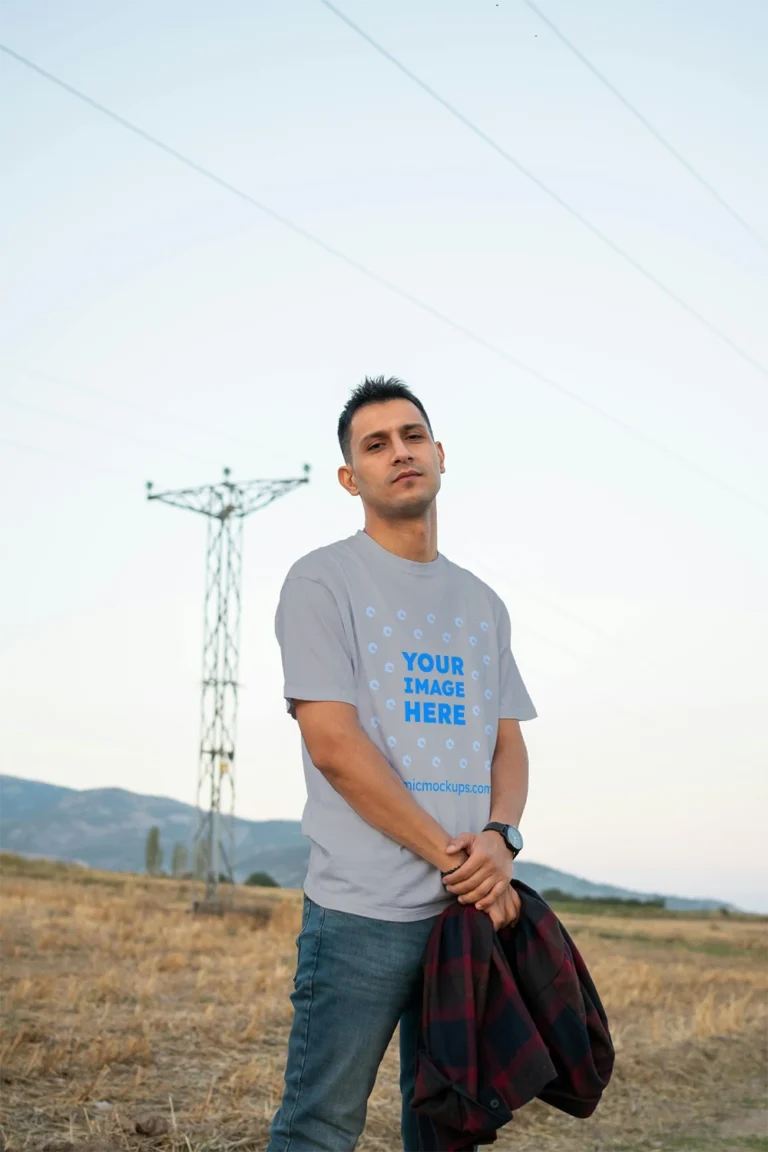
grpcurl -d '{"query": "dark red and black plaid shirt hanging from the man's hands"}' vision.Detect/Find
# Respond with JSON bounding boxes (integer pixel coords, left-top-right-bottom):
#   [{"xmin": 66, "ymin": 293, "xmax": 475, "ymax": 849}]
[{"xmin": 413, "ymin": 880, "xmax": 614, "ymax": 1152}]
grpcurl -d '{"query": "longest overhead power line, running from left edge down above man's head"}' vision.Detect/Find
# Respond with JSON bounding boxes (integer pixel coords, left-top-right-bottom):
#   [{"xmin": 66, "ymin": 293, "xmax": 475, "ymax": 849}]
[{"xmin": 0, "ymin": 44, "xmax": 768, "ymax": 513}]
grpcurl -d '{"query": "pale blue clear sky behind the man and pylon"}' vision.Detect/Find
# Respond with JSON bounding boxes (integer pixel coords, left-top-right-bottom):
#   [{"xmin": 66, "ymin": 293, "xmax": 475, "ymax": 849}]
[{"xmin": 0, "ymin": 0, "xmax": 768, "ymax": 910}]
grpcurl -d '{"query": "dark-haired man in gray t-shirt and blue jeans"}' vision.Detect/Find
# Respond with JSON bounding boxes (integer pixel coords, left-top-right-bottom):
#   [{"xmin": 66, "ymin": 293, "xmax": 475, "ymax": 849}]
[{"xmin": 267, "ymin": 378, "xmax": 537, "ymax": 1152}]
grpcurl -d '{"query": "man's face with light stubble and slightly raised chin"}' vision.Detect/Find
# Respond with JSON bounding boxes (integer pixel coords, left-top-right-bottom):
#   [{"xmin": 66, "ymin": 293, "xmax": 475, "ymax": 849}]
[{"xmin": 339, "ymin": 400, "xmax": 446, "ymax": 520}]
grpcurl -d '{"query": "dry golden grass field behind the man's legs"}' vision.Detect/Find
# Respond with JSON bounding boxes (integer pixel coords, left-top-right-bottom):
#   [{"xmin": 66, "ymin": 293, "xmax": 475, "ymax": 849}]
[{"xmin": 0, "ymin": 857, "xmax": 768, "ymax": 1152}]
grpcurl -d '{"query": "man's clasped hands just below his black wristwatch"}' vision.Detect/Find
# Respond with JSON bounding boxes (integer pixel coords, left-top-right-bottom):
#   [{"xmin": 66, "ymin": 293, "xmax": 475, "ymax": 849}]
[{"xmin": 443, "ymin": 832, "xmax": 520, "ymax": 932}]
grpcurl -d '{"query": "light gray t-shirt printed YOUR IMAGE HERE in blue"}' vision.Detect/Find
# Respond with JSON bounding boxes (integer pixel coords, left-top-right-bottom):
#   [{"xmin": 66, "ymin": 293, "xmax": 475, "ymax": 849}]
[{"xmin": 275, "ymin": 531, "xmax": 537, "ymax": 920}]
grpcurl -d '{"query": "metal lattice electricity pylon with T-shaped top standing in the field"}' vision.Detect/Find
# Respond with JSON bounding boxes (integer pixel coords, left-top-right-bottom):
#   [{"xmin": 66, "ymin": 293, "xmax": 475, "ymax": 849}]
[{"xmin": 146, "ymin": 464, "xmax": 310, "ymax": 902}]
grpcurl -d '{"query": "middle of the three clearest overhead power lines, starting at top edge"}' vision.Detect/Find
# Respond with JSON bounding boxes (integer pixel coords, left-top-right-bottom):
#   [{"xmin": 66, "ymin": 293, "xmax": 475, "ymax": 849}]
[{"xmin": 320, "ymin": 0, "xmax": 768, "ymax": 377}]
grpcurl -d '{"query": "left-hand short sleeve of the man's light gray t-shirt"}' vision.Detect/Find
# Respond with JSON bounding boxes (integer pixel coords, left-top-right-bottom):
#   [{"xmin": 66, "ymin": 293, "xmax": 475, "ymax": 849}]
[{"xmin": 275, "ymin": 576, "xmax": 357, "ymax": 715}]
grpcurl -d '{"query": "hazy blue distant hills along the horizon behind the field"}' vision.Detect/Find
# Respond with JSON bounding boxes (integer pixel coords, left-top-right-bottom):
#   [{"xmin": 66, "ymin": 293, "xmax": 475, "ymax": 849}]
[{"xmin": 0, "ymin": 775, "xmax": 731, "ymax": 911}]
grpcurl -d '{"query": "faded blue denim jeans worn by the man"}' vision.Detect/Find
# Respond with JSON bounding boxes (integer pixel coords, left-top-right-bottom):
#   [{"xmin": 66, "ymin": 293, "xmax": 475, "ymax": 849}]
[{"xmin": 267, "ymin": 895, "xmax": 438, "ymax": 1152}]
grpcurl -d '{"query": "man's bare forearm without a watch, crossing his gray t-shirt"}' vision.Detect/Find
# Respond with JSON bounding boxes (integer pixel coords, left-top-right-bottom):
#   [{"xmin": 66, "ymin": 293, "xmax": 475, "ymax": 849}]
[{"xmin": 318, "ymin": 729, "xmax": 458, "ymax": 871}]
